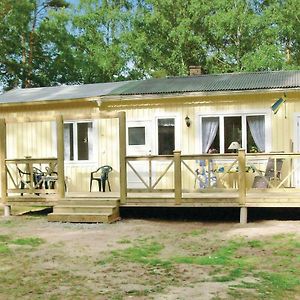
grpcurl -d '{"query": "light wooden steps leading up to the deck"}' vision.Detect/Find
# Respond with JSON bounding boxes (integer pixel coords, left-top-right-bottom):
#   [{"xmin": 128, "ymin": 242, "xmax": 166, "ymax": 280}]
[{"xmin": 48, "ymin": 197, "xmax": 120, "ymax": 223}]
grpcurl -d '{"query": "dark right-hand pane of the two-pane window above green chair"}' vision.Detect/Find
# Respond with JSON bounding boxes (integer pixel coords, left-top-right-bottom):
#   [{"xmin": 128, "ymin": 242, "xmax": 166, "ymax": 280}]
[{"xmin": 77, "ymin": 123, "xmax": 92, "ymax": 160}]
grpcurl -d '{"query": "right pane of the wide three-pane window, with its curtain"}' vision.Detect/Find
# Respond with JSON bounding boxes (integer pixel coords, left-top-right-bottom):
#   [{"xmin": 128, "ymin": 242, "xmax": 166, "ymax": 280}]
[{"xmin": 247, "ymin": 116, "xmax": 265, "ymax": 152}]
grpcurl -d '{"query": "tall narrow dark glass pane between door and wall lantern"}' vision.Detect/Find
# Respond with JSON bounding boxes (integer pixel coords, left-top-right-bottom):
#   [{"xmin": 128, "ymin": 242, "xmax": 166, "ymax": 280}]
[{"xmin": 158, "ymin": 118, "xmax": 175, "ymax": 155}]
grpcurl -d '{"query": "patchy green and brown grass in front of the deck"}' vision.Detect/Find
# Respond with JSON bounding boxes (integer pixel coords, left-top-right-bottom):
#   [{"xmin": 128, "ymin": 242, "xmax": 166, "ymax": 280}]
[{"xmin": 0, "ymin": 217, "xmax": 300, "ymax": 300}]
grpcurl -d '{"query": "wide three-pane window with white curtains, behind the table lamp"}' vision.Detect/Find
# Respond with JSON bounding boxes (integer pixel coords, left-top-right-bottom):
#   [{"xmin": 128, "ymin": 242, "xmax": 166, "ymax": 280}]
[{"xmin": 201, "ymin": 115, "xmax": 266, "ymax": 153}]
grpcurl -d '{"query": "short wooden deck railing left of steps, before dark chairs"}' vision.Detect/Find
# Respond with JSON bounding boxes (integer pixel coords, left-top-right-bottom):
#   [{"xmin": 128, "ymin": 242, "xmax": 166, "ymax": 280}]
[{"xmin": 5, "ymin": 158, "xmax": 59, "ymax": 197}]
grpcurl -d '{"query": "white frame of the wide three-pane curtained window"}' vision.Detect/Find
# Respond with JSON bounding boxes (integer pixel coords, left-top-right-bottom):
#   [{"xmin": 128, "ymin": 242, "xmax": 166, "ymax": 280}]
[{"xmin": 196, "ymin": 111, "xmax": 271, "ymax": 154}]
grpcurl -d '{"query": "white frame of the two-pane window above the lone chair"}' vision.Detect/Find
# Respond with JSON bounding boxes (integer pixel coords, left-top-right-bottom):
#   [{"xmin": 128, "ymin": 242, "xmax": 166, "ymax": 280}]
[{"xmin": 64, "ymin": 120, "xmax": 98, "ymax": 165}]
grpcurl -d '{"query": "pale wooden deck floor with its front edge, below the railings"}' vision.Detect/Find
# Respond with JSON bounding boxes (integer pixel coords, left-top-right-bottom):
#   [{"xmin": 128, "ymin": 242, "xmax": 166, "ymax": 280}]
[{"xmin": 8, "ymin": 190, "xmax": 300, "ymax": 207}]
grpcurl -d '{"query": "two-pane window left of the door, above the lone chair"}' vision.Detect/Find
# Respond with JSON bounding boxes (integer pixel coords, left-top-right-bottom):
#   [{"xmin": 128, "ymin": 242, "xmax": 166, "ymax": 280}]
[{"xmin": 64, "ymin": 122, "xmax": 93, "ymax": 161}]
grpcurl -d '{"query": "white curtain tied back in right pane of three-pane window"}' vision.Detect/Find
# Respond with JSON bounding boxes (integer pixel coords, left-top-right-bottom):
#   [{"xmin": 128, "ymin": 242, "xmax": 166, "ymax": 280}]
[{"xmin": 247, "ymin": 116, "xmax": 265, "ymax": 152}]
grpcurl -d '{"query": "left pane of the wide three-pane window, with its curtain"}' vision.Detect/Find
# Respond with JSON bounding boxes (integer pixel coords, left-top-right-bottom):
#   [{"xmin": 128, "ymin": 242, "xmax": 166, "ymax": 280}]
[{"xmin": 202, "ymin": 117, "xmax": 220, "ymax": 153}]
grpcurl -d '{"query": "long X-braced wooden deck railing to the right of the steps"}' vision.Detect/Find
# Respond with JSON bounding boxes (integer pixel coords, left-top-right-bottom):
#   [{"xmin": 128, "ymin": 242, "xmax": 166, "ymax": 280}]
[{"xmin": 123, "ymin": 149, "xmax": 300, "ymax": 205}]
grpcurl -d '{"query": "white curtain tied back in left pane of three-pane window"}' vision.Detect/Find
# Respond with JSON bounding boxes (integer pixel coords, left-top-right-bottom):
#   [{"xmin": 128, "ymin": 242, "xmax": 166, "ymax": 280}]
[{"xmin": 202, "ymin": 117, "xmax": 219, "ymax": 153}]
